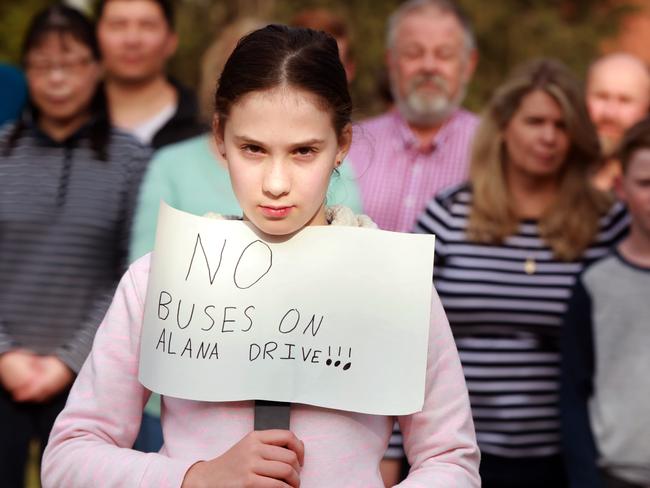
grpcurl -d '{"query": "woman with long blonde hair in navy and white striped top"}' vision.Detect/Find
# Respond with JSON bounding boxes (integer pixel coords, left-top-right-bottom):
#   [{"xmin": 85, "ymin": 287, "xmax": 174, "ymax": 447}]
[{"xmin": 417, "ymin": 59, "xmax": 627, "ymax": 488}]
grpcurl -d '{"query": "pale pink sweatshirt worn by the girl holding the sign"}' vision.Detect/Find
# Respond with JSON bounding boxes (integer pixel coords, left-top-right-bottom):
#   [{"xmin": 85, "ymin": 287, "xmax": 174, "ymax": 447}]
[{"xmin": 42, "ymin": 255, "xmax": 480, "ymax": 488}]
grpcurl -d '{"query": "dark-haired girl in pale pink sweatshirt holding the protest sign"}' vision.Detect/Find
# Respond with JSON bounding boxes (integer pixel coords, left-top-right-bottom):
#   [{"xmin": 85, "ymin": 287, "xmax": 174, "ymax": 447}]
[{"xmin": 42, "ymin": 26, "xmax": 480, "ymax": 488}]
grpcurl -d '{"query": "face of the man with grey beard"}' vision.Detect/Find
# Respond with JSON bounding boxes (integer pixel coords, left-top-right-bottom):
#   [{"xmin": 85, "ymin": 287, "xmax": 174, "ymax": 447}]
[{"xmin": 388, "ymin": 9, "xmax": 476, "ymax": 126}]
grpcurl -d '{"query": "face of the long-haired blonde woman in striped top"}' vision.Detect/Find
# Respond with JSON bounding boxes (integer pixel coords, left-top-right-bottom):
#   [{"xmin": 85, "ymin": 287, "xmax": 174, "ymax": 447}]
[{"xmin": 503, "ymin": 90, "xmax": 570, "ymax": 180}]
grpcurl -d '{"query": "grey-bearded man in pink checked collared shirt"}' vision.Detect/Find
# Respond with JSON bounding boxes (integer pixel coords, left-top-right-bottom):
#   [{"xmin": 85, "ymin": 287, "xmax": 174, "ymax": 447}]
[{"xmin": 349, "ymin": 0, "xmax": 478, "ymax": 232}]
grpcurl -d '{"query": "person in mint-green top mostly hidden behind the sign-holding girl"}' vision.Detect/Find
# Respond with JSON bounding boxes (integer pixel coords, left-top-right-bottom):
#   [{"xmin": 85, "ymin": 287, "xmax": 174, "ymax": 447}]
[{"xmin": 129, "ymin": 18, "xmax": 361, "ymax": 452}]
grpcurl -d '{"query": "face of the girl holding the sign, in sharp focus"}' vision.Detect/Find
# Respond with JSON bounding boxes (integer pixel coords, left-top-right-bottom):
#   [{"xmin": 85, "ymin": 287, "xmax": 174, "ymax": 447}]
[{"xmin": 215, "ymin": 87, "xmax": 351, "ymax": 236}]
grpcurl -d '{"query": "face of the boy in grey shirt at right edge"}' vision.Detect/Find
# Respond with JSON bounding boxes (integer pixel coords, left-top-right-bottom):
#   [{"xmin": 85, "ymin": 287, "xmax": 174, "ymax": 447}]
[{"xmin": 616, "ymin": 148, "xmax": 650, "ymax": 240}]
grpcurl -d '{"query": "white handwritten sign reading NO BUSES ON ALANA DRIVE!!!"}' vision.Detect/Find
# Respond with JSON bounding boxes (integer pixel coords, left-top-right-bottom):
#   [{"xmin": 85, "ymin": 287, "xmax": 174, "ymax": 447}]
[{"xmin": 139, "ymin": 203, "xmax": 434, "ymax": 415}]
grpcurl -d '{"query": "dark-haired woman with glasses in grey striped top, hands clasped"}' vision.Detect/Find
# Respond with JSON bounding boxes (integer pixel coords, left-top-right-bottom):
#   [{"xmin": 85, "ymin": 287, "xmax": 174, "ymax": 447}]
[{"xmin": 0, "ymin": 6, "xmax": 148, "ymax": 487}]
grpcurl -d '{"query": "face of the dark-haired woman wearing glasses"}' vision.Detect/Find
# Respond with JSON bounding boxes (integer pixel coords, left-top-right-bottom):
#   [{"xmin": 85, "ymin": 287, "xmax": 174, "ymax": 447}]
[{"xmin": 25, "ymin": 33, "xmax": 102, "ymax": 137}]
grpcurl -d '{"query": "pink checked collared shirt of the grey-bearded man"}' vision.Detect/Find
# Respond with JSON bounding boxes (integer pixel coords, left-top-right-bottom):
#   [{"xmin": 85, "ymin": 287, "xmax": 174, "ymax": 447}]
[{"xmin": 348, "ymin": 109, "xmax": 478, "ymax": 232}]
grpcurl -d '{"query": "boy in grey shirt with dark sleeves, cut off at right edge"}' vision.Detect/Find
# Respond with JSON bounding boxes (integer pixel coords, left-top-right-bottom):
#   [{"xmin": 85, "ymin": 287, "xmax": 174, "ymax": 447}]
[{"xmin": 561, "ymin": 118, "xmax": 650, "ymax": 488}]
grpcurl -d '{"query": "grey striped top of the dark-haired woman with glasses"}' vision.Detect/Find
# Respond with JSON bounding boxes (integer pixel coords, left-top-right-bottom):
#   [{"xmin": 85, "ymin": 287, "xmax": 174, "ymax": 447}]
[{"xmin": 0, "ymin": 124, "xmax": 149, "ymax": 371}]
